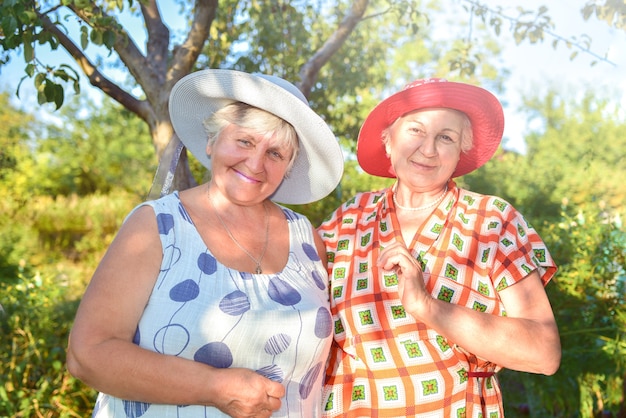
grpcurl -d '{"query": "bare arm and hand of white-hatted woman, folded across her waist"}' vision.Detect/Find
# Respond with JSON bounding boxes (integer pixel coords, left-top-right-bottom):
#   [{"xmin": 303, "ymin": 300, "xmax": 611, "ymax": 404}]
[{"xmin": 67, "ymin": 206, "xmax": 284, "ymax": 416}]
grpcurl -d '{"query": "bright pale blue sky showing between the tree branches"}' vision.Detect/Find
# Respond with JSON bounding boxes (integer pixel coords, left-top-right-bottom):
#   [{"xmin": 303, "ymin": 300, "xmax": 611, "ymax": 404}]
[{"xmin": 0, "ymin": 0, "xmax": 626, "ymax": 152}]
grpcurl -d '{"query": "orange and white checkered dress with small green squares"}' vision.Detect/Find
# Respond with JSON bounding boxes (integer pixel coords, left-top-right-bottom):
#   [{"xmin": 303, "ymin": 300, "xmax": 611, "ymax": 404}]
[{"xmin": 319, "ymin": 180, "xmax": 556, "ymax": 418}]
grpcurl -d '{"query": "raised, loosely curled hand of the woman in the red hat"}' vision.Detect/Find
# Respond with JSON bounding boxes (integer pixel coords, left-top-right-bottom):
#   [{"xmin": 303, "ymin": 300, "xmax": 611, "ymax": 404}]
[{"xmin": 378, "ymin": 242, "xmax": 431, "ymax": 318}]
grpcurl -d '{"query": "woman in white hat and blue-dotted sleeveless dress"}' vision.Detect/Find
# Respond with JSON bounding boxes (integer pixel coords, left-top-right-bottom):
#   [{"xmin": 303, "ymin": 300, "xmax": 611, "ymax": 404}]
[{"xmin": 67, "ymin": 70, "xmax": 343, "ymax": 418}]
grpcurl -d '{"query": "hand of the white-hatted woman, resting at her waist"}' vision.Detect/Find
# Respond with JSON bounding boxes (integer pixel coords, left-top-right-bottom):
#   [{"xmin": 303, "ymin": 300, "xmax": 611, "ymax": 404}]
[{"xmin": 215, "ymin": 368, "xmax": 285, "ymax": 418}]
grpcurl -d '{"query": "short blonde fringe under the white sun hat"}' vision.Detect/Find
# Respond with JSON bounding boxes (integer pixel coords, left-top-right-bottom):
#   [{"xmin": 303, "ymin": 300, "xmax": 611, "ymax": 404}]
[{"xmin": 202, "ymin": 102, "xmax": 300, "ymax": 172}]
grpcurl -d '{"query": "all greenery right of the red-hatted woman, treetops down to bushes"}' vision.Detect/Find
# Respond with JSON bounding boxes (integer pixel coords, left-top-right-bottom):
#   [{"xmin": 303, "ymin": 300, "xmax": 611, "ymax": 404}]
[{"xmin": 460, "ymin": 84, "xmax": 626, "ymax": 417}]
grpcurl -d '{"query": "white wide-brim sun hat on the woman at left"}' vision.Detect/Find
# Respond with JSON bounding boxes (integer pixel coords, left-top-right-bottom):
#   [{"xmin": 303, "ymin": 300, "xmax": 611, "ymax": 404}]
[{"xmin": 169, "ymin": 69, "xmax": 344, "ymax": 204}]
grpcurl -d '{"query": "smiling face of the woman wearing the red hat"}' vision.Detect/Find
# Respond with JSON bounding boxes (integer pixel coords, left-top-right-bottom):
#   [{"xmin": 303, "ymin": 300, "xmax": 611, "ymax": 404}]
[{"xmin": 383, "ymin": 109, "xmax": 471, "ymax": 191}]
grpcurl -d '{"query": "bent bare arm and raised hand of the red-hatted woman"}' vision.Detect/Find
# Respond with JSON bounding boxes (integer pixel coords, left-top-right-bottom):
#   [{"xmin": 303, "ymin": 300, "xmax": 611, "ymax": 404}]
[{"xmin": 379, "ymin": 243, "xmax": 561, "ymax": 375}]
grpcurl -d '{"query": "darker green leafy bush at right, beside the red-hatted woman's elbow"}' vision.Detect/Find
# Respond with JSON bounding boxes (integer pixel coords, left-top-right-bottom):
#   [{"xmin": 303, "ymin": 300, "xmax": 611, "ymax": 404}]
[{"xmin": 502, "ymin": 205, "xmax": 626, "ymax": 417}]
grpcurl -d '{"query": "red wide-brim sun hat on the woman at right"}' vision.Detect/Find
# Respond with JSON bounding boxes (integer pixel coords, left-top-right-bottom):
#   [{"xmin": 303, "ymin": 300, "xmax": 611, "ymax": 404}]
[{"xmin": 357, "ymin": 78, "xmax": 504, "ymax": 178}]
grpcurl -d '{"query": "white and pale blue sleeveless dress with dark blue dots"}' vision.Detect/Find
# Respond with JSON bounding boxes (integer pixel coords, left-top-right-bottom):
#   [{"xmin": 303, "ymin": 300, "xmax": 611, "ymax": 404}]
[{"xmin": 93, "ymin": 192, "xmax": 332, "ymax": 418}]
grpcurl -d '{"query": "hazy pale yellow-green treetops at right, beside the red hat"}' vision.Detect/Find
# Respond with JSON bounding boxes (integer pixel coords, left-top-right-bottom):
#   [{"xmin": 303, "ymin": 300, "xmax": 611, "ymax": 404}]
[{"xmin": 463, "ymin": 85, "xmax": 626, "ymax": 223}]
